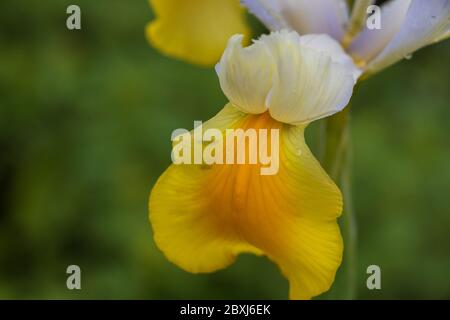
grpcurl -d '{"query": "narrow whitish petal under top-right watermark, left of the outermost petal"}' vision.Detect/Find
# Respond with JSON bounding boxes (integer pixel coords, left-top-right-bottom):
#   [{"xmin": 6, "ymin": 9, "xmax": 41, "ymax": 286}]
[{"xmin": 348, "ymin": 0, "xmax": 414, "ymax": 62}]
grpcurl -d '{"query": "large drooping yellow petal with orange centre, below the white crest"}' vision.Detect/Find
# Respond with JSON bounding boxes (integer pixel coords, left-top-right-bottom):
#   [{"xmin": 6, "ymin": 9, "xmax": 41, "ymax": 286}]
[{"xmin": 149, "ymin": 105, "xmax": 343, "ymax": 299}]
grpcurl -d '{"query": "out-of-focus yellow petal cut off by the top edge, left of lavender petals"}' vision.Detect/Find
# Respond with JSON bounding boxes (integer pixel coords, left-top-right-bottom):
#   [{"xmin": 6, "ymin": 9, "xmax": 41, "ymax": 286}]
[{"xmin": 146, "ymin": 0, "xmax": 250, "ymax": 66}]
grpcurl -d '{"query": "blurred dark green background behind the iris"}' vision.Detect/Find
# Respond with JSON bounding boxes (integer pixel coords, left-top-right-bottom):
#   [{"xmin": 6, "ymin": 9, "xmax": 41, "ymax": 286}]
[{"xmin": 0, "ymin": 0, "xmax": 450, "ymax": 299}]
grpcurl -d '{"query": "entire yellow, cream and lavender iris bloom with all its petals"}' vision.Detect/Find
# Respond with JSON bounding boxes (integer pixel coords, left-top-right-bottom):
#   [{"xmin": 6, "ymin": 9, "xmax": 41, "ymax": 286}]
[{"xmin": 146, "ymin": 0, "xmax": 450, "ymax": 299}]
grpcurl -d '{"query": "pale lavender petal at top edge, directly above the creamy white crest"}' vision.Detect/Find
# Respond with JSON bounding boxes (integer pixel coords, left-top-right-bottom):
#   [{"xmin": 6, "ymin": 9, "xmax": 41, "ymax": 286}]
[{"xmin": 241, "ymin": 0, "xmax": 348, "ymax": 40}]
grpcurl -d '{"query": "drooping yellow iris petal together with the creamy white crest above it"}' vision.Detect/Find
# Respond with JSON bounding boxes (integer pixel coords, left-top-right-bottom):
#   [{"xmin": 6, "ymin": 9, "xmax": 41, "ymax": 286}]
[{"xmin": 149, "ymin": 30, "xmax": 355, "ymax": 299}]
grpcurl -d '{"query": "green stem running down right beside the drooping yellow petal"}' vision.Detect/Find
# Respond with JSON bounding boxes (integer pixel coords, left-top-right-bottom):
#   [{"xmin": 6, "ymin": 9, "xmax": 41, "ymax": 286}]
[{"xmin": 322, "ymin": 106, "xmax": 357, "ymax": 299}]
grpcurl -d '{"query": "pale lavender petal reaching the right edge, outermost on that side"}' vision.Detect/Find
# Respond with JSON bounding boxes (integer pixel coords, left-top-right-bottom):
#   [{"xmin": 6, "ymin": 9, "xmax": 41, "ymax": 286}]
[{"xmin": 367, "ymin": 0, "xmax": 450, "ymax": 73}]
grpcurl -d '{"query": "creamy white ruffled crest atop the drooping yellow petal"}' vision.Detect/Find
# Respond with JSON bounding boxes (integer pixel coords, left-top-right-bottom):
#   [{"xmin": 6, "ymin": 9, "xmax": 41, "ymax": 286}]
[{"xmin": 216, "ymin": 30, "xmax": 355, "ymax": 125}]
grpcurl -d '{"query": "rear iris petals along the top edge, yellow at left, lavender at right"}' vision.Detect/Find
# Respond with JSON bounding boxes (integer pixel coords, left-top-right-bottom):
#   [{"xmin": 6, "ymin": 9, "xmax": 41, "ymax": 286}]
[{"xmin": 147, "ymin": 0, "xmax": 450, "ymax": 77}]
